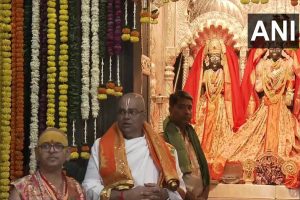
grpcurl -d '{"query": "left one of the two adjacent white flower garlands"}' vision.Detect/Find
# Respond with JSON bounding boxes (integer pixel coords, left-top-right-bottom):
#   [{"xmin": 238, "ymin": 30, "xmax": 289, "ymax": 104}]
[{"xmin": 81, "ymin": 0, "xmax": 90, "ymax": 120}]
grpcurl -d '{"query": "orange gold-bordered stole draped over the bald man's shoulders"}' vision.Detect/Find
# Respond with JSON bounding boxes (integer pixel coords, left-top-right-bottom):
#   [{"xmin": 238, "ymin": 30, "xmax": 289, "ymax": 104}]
[{"xmin": 99, "ymin": 122, "xmax": 179, "ymax": 191}]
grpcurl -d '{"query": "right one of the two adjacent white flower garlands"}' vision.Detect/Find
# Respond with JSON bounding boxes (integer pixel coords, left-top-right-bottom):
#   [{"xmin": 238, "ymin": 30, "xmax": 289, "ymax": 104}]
[{"xmin": 90, "ymin": 0, "xmax": 100, "ymax": 118}]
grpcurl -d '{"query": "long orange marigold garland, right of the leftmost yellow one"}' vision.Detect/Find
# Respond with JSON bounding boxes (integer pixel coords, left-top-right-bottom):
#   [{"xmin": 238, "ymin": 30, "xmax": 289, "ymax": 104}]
[{"xmin": 10, "ymin": 0, "xmax": 24, "ymax": 180}]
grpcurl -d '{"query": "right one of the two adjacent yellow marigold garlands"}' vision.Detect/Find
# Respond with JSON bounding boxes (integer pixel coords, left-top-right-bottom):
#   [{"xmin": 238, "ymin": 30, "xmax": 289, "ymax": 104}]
[{"xmin": 58, "ymin": 0, "xmax": 69, "ymax": 133}]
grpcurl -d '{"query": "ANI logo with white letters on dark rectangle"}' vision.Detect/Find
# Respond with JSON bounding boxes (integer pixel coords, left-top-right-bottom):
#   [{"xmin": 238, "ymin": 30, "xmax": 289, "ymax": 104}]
[{"xmin": 248, "ymin": 14, "xmax": 299, "ymax": 48}]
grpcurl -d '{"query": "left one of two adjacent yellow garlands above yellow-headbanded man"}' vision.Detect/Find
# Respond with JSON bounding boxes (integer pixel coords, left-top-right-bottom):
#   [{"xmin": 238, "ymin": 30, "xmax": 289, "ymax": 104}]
[{"xmin": 46, "ymin": 0, "xmax": 57, "ymax": 127}]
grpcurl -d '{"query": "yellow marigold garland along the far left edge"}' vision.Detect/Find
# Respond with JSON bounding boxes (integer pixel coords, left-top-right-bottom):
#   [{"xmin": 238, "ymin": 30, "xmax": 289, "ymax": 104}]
[{"xmin": 0, "ymin": 0, "xmax": 12, "ymax": 199}]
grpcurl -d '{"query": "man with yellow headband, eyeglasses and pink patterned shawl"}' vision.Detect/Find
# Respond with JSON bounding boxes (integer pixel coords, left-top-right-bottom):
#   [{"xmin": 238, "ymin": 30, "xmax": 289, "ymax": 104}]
[{"xmin": 9, "ymin": 128, "xmax": 85, "ymax": 200}]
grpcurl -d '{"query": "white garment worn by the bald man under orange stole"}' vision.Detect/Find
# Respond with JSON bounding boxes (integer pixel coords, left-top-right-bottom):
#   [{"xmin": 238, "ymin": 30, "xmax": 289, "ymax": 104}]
[{"xmin": 82, "ymin": 137, "xmax": 185, "ymax": 200}]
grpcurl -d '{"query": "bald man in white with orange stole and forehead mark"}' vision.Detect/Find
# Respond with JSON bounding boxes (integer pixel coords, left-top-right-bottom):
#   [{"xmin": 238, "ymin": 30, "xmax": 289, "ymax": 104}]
[{"xmin": 83, "ymin": 93, "xmax": 185, "ymax": 200}]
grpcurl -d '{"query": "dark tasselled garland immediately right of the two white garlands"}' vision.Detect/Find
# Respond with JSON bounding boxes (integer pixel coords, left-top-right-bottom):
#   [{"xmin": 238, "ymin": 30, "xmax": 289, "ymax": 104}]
[{"xmin": 98, "ymin": 1, "xmax": 107, "ymax": 100}]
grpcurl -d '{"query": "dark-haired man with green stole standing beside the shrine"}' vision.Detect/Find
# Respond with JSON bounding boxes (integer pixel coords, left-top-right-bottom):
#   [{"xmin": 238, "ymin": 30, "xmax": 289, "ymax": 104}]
[{"xmin": 163, "ymin": 90, "xmax": 210, "ymax": 200}]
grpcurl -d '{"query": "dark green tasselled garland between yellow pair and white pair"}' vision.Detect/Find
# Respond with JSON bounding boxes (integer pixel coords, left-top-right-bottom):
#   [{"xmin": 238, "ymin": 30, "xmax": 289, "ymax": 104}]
[{"xmin": 68, "ymin": 0, "xmax": 81, "ymax": 159}]
